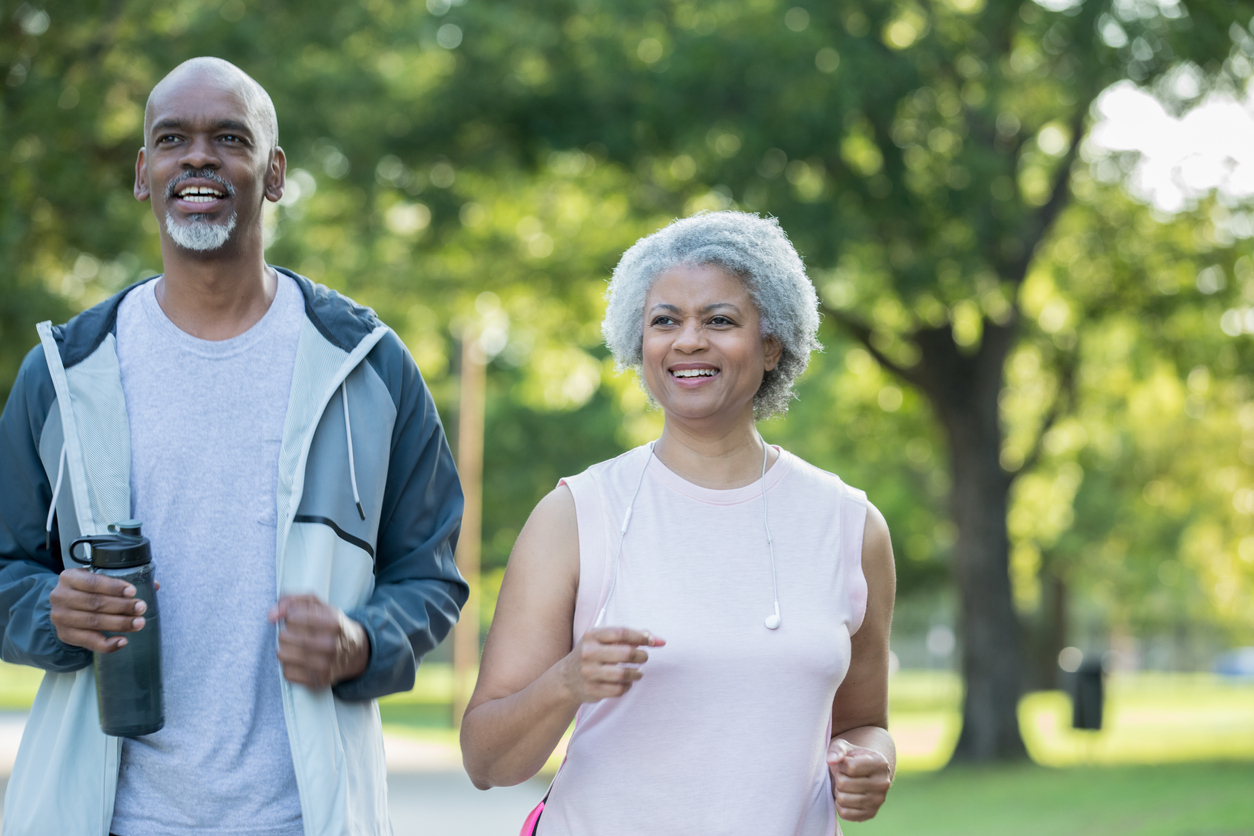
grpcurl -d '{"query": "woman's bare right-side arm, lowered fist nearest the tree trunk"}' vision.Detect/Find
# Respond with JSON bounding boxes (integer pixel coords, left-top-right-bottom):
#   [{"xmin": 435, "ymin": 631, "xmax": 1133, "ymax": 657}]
[{"xmin": 828, "ymin": 503, "xmax": 897, "ymax": 821}]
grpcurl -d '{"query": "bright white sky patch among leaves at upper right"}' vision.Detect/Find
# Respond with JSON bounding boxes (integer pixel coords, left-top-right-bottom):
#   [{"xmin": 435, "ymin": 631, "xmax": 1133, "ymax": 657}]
[{"xmin": 1088, "ymin": 74, "xmax": 1254, "ymax": 212}]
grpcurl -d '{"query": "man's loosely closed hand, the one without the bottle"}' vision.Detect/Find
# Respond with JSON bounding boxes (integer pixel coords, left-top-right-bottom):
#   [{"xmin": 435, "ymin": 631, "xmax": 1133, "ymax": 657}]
[{"xmin": 270, "ymin": 595, "xmax": 370, "ymax": 688}]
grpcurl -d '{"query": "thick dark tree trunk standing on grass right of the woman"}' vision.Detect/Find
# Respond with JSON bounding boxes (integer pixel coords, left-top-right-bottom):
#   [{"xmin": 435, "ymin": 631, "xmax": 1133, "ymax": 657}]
[{"xmin": 912, "ymin": 321, "xmax": 1027, "ymax": 762}]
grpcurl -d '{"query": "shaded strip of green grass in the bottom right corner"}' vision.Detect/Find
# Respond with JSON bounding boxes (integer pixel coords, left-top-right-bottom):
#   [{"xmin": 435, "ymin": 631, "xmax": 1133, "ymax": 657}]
[{"xmin": 841, "ymin": 762, "xmax": 1254, "ymax": 836}]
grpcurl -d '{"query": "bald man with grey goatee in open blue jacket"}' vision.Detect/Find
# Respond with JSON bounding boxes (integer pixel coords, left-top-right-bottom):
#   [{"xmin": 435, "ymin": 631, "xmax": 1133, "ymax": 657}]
[{"xmin": 0, "ymin": 58, "xmax": 468, "ymax": 836}]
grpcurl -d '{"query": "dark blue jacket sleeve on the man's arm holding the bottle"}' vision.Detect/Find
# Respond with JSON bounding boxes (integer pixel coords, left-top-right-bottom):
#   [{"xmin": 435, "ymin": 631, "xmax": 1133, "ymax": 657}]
[{"xmin": 0, "ymin": 346, "xmax": 92, "ymax": 672}]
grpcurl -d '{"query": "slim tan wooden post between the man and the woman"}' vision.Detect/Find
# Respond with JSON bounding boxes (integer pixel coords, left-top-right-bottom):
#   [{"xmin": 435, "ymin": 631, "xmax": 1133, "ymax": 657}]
[{"xmin": 453, "ymin": 326, "xmax": 487, "ymax": 728}]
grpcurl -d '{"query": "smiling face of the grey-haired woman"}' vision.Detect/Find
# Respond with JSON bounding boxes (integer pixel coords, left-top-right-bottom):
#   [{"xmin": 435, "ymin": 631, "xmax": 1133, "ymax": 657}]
[{"xmin": 643, "ymin": 264, "xmax": 780, "ymax": 421}]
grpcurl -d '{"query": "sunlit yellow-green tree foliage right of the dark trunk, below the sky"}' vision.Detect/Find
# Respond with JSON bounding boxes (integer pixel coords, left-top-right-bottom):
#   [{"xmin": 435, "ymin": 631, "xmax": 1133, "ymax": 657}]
[{"xmin": 1003, "ymin": 180, "xmax": 1254, "ymax": 663}]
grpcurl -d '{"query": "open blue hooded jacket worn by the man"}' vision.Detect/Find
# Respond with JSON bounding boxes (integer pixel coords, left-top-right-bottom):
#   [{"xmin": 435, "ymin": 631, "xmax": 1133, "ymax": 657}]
[{"xmin": 0, "ymin": 268, "xmax": 469, "ymax": 836}]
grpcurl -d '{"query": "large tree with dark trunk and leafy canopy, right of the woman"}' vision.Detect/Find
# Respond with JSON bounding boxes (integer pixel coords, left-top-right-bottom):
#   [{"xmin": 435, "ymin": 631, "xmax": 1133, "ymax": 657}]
[{"xmin": 411, "ymin": 0, "xmax": 1248, "ymax": 761}]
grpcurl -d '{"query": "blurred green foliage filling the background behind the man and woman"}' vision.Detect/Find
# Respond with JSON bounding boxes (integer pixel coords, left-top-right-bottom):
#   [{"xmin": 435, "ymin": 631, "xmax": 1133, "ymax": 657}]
[{"xmin": 7, "ymin": 0, "xmax": 1254, "ymax": 726}]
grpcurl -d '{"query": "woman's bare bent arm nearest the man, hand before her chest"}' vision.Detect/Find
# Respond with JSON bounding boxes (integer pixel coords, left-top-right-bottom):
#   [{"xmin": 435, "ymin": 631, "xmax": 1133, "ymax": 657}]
[{"xmin": 461, "ymin": 485, "xmax": 662, "ymax": 790}]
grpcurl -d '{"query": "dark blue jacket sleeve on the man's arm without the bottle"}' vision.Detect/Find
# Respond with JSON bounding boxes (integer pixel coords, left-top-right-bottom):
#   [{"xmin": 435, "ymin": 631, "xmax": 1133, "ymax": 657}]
[{"xmin": 334, "ymin": 333, "xmax": 469, "ymax": 699}]
